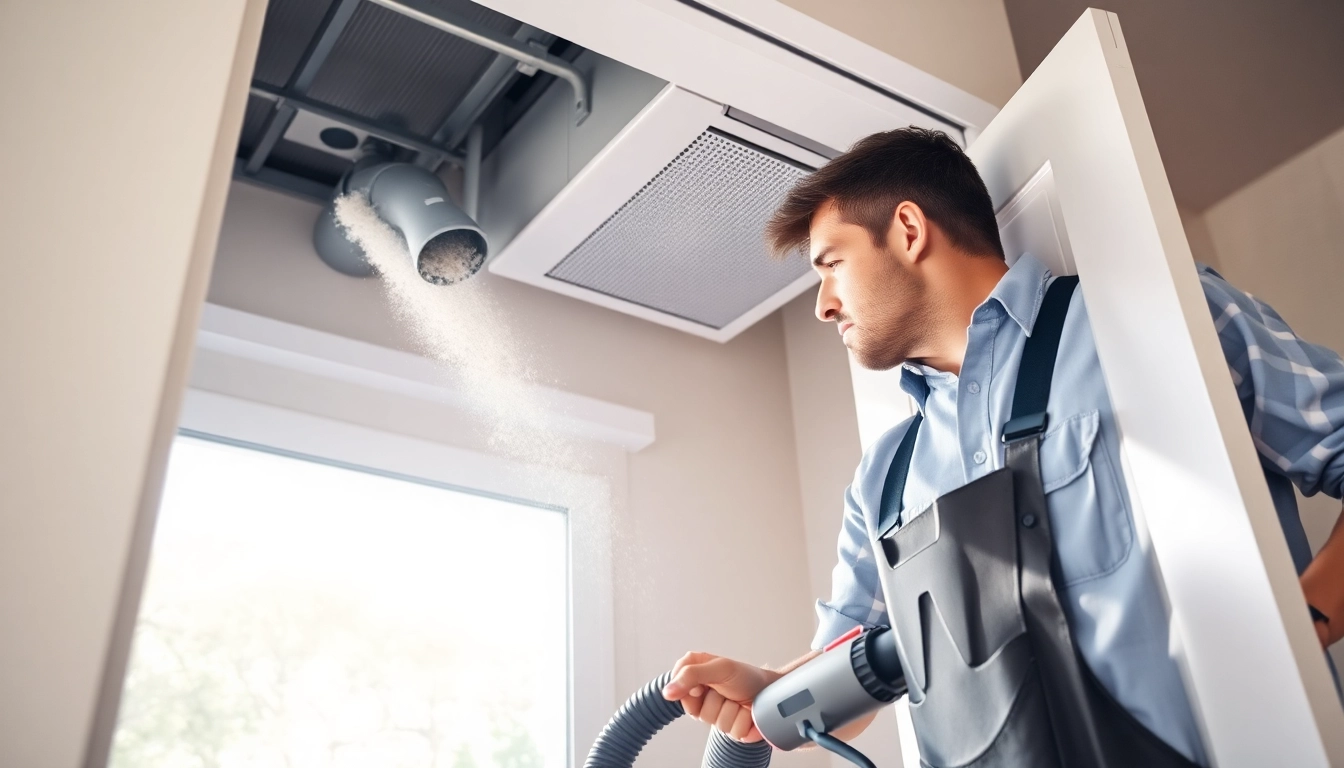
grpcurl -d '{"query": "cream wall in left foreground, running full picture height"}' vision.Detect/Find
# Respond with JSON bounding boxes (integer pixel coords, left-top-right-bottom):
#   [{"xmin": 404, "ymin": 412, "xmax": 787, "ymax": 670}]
[{"xmin": 0, "ymin": 0, "xmax": 265, "ymax": 768}]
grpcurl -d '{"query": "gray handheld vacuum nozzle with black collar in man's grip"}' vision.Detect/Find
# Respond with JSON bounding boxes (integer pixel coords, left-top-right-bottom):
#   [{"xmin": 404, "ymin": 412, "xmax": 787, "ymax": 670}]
[{"xmin": 751, "ymin": 627, "xmax": 906, "ymax": 751}]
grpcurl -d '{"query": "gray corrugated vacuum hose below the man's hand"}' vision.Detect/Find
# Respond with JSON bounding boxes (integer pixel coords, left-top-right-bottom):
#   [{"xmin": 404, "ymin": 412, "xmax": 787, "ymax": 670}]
[{"xmin": 583, "ymin": 671, "xmax": 770, "ymax": 768}]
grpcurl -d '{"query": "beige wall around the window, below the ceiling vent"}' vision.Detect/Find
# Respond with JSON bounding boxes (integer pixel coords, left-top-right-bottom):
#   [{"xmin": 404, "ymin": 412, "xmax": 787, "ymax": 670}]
[{"xmin": 210, "ymin": 184, "xmax": 823, "ymax": 765}]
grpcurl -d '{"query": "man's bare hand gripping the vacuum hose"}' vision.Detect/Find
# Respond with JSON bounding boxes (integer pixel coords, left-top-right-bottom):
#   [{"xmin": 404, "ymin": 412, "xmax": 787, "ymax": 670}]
[{"xmin": 663, "ymin": 652, "xmax": 784, "ymax": 742}]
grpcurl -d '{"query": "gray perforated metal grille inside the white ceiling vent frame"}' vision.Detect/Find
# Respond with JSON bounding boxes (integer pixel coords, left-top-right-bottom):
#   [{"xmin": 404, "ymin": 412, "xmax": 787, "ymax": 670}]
[{"xmin": 547, "ymin": 129, "xmax": 810, "ymax": 330}]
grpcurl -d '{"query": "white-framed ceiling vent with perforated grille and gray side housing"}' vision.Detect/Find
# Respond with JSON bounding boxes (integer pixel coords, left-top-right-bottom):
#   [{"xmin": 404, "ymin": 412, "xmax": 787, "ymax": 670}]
[{"xmin": 481, "ymin": 83, "xmax": 835, "ymax": 342}]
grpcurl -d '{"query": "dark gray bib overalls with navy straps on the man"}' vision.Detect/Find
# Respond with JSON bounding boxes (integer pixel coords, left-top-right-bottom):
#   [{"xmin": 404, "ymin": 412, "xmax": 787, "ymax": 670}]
[{"xmin": 872, "ymin": 277, "xmax": 1193, "ymax": 768}]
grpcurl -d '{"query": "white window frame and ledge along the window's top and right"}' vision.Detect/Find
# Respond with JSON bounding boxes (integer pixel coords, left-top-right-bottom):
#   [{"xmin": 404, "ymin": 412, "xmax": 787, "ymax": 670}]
[{"xmin": 132, "ymin": 304, "xmax": 639, "ymax": 767}]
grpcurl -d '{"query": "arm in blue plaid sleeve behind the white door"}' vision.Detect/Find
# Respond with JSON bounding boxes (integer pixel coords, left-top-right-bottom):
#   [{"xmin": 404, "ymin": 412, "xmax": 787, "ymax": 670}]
[{"xmin": 1200, "ymin": 270, "xmax": 1344, "ymax": 646}]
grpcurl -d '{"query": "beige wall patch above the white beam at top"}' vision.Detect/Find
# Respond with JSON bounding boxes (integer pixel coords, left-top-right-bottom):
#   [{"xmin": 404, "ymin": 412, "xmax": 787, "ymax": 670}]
[{"xmin": 784, "ymin": 0, "xmax": 1021, "ymax": 106}]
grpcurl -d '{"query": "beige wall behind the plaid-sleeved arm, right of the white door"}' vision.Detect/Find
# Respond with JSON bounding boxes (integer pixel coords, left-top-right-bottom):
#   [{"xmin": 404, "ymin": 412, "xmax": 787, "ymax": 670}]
[{"xmin": 1203, "ymin": 130, "xmax": 1344, "ymax": 559}]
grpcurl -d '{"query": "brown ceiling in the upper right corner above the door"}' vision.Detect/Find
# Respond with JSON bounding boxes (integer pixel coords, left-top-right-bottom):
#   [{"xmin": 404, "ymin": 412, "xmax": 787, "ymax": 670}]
[{"xmin": 1004, "ymin": 0, "xmax": 1344, "ymax": 213}]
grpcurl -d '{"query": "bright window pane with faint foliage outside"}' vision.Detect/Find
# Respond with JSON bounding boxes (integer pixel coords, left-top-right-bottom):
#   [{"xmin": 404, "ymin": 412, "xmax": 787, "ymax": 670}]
[{"xmin": 112, "ymin": 436, "xmax": 569, "ymax": 768}]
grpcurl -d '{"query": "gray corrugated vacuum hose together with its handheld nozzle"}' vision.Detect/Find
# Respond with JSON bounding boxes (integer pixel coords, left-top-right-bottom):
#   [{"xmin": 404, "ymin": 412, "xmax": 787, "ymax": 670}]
[{"xmin": 583, "ymin": 627, "xmax": 906, "ymax": 768}]
